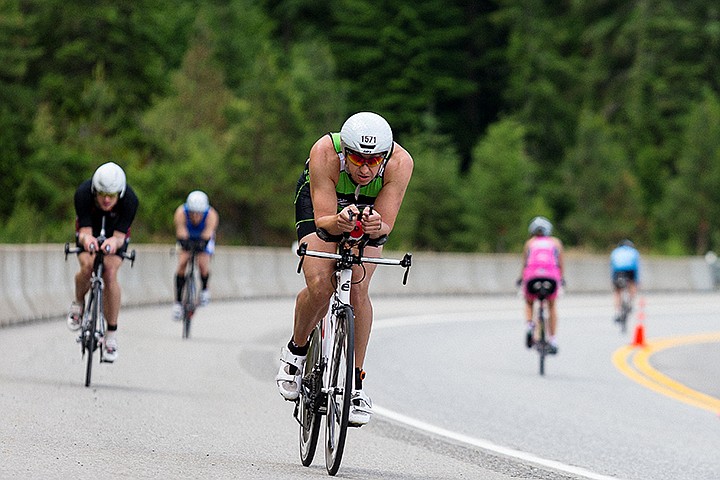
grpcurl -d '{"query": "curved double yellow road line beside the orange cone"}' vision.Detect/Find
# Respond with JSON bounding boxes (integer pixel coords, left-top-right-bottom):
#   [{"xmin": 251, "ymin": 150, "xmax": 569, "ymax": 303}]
[{"xmin": 612, "ymin": 332, "xmax": 720, "ymax": 413}]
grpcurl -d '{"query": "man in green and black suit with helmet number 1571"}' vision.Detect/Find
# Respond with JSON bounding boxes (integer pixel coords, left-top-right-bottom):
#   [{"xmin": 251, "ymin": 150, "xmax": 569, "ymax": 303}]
[{"xmin": 275, "ymin": 112, "xmax": 413, "ymax": 426}]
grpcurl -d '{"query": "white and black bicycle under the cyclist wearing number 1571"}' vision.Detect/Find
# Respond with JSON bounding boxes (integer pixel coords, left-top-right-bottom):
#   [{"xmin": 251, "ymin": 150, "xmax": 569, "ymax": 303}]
[{"xmin": 294, "ymin": 211, "xmax": 412, "ymax": 475}]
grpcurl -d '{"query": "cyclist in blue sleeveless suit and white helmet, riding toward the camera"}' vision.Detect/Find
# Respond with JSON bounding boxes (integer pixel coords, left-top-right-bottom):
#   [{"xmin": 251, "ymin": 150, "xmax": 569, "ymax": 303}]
[{"xmin": 173, "ymin": 190, "xmax": 220, "ymax": 320}]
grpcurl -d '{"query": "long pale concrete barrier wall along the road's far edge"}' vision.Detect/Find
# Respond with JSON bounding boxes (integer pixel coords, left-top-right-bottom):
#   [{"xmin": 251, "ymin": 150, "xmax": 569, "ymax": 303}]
[{"xmin": 0, "ymin": 244, "xmax": 714, "ymax": 326}]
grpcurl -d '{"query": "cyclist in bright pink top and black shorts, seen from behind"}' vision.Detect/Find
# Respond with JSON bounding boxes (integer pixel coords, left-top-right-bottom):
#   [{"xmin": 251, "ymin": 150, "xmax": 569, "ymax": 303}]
[{"xmin": 522, "ymin": 217, "xmax": 563, "ymax": 354}]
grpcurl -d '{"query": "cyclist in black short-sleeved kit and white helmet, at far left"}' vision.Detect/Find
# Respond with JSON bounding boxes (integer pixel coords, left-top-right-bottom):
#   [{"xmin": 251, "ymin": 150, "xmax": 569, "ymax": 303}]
[{"xmin": 67, "ymin": 162, "xmax": 138, "ymax": 362}]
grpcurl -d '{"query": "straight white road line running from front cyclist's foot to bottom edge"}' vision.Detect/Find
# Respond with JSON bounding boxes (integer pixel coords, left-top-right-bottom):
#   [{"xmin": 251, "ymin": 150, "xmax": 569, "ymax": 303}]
[{"xmin": 373, "ymin": 405, "xmax": 619, "ymax": 480}]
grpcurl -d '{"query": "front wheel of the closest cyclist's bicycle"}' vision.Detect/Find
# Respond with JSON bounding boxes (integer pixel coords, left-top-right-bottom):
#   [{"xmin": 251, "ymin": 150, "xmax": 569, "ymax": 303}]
[{"xmin": 325, "ymin": 305, "xmax": 355, "ymax": 475}]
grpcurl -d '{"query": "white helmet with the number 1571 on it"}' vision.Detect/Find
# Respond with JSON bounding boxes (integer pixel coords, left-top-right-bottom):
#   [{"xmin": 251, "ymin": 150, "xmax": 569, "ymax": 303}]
[{"xmin": 340, "ymin": 112, "xmax": 393, "ymax": 158}]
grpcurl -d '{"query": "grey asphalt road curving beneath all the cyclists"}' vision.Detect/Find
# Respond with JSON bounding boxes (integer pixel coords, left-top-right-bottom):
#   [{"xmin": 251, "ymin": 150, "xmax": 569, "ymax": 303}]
[{"xmin": 0, "ymin": 294, "xmax": 720, "ymax": 480}]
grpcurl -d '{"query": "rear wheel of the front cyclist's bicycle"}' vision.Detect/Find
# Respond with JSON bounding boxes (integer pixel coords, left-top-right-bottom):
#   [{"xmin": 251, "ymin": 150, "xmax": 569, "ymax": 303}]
[{"xmin": 297, "ymin": 324, "xmax": 323, "ymax": 467}]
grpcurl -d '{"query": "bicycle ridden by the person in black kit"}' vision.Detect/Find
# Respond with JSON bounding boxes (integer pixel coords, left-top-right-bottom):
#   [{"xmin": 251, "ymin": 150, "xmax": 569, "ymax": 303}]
[{"xmin": 65, "ymin": 217, "xmax": 135, "ymax": 387}]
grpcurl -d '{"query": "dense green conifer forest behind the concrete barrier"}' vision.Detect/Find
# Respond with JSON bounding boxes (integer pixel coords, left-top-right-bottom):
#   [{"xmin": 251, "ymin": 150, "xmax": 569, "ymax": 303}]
[{"xmin": 0, "ymin": 0, "xmax": 720, "ymax": 255}]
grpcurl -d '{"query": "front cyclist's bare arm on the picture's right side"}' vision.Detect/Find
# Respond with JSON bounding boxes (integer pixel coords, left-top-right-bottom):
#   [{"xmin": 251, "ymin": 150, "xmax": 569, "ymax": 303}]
[{"xmin": 368, "ymin": 143, "xmax": 414, "ymax": 238}]
